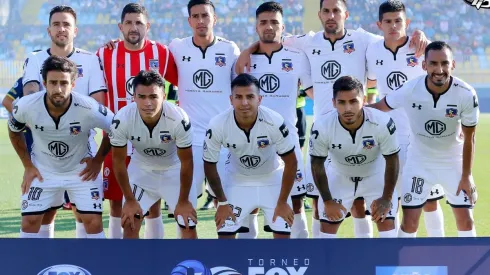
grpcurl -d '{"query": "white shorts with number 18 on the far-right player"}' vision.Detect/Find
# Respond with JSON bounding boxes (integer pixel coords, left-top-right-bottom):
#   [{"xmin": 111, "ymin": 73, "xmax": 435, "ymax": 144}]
[{"xmin": 401, "ymin": 160, "xmax": 473, "ymax": 208}]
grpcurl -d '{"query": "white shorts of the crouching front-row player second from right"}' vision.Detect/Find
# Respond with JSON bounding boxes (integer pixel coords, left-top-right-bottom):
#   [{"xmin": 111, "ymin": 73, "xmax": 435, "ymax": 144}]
[{"xmin": 318, "ymin": 166, "xmax": 398, "ymax": 224}]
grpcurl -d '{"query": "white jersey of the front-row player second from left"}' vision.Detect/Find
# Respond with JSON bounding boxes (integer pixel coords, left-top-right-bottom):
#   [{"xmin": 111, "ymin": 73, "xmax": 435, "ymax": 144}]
[{"xmin": 110, "ymin": 102, "xmax": 192, "ymax": 170}]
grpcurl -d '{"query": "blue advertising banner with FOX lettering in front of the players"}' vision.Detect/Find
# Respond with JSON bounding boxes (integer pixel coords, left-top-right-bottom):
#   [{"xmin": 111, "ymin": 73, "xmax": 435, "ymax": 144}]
[{"xmin": 0, "ymin": 238, "xmax": 490, "ymax": 275}]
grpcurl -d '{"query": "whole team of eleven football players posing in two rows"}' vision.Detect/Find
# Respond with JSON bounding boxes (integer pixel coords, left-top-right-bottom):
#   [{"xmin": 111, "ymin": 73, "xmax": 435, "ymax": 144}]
[{"xmin": 9, "ymin": 0, "xmax": 479, "ymax": 238}]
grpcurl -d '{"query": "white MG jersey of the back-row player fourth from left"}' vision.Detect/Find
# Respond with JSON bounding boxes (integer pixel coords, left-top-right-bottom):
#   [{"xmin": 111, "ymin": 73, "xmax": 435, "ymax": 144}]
[{"xmin": 233, "ymin": 46, "xmax": 313, "ymax": 129}]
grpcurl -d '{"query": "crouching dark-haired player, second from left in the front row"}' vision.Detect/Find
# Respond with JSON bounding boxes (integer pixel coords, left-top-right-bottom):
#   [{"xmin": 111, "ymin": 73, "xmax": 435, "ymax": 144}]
[{"xmin": 111, "ymin": 71, "xmax": 197, "ymax": 239}]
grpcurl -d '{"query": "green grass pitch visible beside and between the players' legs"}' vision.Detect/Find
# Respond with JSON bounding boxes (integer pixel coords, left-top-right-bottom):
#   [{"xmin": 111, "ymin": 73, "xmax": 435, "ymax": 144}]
[{"xmin": 0, "ymin": 114, "xmax": 490, "ymax": 238}]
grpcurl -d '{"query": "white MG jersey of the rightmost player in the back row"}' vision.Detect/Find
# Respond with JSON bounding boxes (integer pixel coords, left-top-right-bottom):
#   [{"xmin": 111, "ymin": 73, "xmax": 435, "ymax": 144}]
[{"xmin": 366, "ymin": 37, "xmax": 426, "ymax": 144}]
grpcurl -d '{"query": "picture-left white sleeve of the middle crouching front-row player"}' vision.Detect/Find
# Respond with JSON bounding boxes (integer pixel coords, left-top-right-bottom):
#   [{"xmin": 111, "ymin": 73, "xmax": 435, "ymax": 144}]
[{"xmin": 203, "ymin": 117, "xmax": 223, "ymax": 163}]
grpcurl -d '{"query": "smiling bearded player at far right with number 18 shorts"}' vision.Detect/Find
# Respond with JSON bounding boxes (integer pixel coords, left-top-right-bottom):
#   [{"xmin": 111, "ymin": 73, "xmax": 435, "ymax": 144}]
[{"xmin": 372, "ymin": 41, "xmax": 480, "ymax": 237}]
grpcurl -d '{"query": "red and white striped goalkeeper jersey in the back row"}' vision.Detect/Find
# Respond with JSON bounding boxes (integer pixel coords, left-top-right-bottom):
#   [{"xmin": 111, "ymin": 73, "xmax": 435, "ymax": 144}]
[{"xmin": 97, "ymin": 40, "xmax": 178, "ymax": 113}]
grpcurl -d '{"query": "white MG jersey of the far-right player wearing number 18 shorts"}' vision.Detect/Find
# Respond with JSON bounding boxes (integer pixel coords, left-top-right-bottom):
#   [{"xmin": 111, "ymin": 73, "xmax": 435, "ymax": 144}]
[{"xmin": 385, "ymin": 75, "xmax": 480, "ymax": 167}]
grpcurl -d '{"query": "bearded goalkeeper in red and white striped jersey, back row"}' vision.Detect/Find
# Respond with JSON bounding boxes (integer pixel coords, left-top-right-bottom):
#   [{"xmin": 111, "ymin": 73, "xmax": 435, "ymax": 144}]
[{"xmin": 97, "ymin": 3, "xmax": 178, "ymax": 239}]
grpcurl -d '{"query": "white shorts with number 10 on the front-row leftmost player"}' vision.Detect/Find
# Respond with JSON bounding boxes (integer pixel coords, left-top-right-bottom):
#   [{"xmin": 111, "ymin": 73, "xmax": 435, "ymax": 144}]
[{"xmin": 21, "ymin": 176, "xmax": 104, "ymax": 216}]
